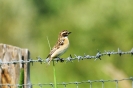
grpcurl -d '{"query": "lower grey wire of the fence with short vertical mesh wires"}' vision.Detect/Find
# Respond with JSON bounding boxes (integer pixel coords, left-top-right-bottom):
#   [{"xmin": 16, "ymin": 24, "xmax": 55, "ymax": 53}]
[{"xmin": 0, "ymin": 77, "xmax": 133, "ymax": 88}]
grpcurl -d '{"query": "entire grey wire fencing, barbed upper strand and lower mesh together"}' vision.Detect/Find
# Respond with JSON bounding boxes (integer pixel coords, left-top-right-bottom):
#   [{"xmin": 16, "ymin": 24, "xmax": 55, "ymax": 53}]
[{"xmin": 0, "ymin": 48, "xmax": 133, "ymax": 88}]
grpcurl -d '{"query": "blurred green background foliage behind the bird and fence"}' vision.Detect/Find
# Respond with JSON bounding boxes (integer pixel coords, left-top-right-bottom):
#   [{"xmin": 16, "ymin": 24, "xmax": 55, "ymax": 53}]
[{"xmin": 0, "ymin": 0, "xmax": 133, "ymax": 88}]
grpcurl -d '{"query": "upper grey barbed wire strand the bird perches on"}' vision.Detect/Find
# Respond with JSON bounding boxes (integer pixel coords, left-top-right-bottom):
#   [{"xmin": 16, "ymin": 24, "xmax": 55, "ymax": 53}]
[{"xmin": 0, "ymin": 48, "xmax": 133, "ymax": 66}]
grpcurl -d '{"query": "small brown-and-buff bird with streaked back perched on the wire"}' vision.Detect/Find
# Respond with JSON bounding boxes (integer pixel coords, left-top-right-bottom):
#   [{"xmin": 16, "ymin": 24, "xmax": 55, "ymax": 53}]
[{"xmin": 47, "ymin": 30, "xmax": 71, "ymax": 64}]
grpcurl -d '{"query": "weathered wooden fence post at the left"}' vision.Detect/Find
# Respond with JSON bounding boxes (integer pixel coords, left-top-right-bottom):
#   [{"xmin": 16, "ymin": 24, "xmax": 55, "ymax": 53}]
[{"xmin": 0, "ymin": 44, "xmax": 31, "ymax": 88}]
